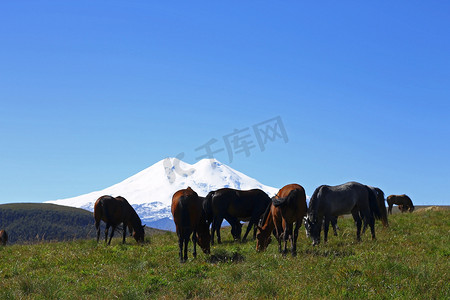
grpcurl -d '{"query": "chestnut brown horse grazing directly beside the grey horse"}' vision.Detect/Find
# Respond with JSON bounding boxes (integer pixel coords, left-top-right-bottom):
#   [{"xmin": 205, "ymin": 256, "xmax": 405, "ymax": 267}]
[{"xmin": 256, "ymin": 184, "xmax": 307, "ymax": 255}]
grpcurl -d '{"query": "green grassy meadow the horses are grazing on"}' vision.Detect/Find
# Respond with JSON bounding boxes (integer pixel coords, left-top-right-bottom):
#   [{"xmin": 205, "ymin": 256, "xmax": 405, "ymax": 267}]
[{"xmin": 0, "ymin": 210, "xmax": 450, "ymax": 299}]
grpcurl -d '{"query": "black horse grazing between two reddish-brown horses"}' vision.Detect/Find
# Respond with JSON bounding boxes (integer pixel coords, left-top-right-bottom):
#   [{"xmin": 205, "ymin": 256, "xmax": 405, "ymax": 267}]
[{"xmin": 205, "ymin": 188, "xmax": 271, "ymax": 244}]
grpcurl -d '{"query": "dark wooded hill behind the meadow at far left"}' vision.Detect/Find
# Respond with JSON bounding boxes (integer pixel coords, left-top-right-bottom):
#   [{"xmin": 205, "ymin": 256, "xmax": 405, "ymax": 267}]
[{"xmin": 0, "ymin": 203, "xmax": 165, "ymax": 244}]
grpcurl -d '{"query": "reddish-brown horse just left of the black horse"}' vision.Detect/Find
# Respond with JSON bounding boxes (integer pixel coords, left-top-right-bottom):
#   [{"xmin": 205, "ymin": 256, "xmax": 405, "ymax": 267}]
[{"xmin": 171, "ymin": 187, "xmax": 211, "ymax": 262}]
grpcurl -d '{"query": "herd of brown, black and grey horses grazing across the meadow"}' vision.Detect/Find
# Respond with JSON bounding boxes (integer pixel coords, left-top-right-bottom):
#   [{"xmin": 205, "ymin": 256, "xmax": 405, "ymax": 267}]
[{"xmin": 90, "ymin": 182, "xmax": 414, "ymax": 262}]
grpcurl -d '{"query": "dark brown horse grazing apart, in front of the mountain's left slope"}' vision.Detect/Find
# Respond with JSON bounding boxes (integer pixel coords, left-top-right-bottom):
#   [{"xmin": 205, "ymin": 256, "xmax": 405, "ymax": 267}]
[{"xmin": 94, "ymin": 196, "xmax": 145, "ymax": 245}]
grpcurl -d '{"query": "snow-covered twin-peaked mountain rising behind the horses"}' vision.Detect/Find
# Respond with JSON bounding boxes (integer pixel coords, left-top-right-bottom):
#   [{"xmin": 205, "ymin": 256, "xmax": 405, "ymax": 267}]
[{"xmin": 47, "ymin": 158, "xmax": 278, "ymax": 230}]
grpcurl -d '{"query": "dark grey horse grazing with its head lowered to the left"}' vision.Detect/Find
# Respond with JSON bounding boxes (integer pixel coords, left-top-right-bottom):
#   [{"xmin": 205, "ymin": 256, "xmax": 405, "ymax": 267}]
[{"xmin": 306, "ymin": 182, "xmax": 381, "ymax": 245}]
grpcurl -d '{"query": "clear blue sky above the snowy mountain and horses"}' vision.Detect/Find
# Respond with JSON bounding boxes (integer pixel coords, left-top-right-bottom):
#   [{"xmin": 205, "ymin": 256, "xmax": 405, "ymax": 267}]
[{"xmin": 0, "ymin": 1, "xmax": 450, "ymax": 204}]
